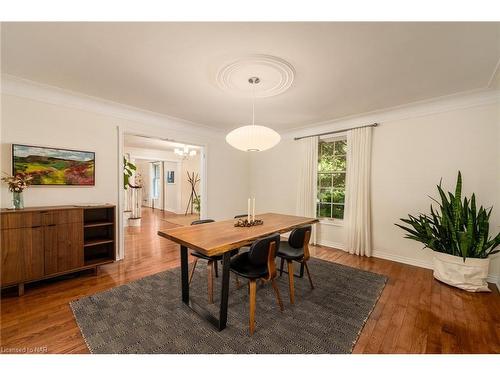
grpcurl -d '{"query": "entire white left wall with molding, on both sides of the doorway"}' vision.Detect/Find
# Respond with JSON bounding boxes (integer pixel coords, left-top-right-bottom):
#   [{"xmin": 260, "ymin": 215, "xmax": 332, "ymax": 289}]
[{"xmin": 0, "ymin": 77, "xmax": 249, "ymax": 220}]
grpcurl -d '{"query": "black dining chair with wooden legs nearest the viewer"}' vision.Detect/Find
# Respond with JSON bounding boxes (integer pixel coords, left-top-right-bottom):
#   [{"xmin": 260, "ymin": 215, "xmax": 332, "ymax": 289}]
[{"xmin": 230, "ymin": 233, "xmax": 283, "ymax": 335}]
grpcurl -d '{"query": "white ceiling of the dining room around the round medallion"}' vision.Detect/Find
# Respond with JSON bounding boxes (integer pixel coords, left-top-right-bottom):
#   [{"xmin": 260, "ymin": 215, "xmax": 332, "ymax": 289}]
[{"xmin": 2, "ymin": 23, "xmax": 500, "ymax": 131}]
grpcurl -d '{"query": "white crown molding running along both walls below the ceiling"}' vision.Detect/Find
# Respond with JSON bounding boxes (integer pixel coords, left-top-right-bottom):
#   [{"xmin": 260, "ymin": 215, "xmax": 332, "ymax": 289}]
[{"xmin": 0, "ymin": 74, "xmax": 500, "ymax": 139}]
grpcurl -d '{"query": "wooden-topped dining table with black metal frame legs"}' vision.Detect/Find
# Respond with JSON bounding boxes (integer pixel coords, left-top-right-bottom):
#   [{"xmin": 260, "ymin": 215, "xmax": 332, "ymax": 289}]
[{"xmin": 158, "ymin": 213, "xmax": 318, "ymax": 331}]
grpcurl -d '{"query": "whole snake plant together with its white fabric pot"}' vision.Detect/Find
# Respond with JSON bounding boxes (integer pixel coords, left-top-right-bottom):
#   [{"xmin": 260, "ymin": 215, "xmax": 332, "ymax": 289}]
[{"xmin": 396, "ymin": 171, "xmax": 500, "ymax": 292}]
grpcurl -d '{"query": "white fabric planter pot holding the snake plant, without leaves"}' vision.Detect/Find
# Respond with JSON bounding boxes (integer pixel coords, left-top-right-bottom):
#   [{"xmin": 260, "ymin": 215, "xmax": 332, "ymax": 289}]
[{"xmin": 433, "ymin": 252, "xmax": 490, "ymax": 292}]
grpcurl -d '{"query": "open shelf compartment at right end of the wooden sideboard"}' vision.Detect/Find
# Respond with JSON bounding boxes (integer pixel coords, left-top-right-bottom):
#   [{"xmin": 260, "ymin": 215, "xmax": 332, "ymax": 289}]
[{"xmin": 83, "ymin": 206, "xmax": 116, "ymax": 266}]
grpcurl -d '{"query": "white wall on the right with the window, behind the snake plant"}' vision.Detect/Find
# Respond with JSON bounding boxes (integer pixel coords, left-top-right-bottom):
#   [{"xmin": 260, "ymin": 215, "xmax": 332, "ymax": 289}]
[{"xmin": 250, "ymin": 95, "xmax": 500, "ymax": 277}]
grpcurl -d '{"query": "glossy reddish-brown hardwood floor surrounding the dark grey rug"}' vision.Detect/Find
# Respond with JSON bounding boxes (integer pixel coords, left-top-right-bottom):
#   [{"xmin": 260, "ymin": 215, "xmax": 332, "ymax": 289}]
[{"xmin": 0, "ymin": 209, "xmax": 500, "ymax": 353}]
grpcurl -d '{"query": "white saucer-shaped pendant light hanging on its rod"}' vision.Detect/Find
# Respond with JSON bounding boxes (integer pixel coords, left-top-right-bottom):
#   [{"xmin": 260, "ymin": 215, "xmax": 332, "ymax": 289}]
[{"xmin": 226, "ymin": 77, "xmax": 281, "ymax": 151}]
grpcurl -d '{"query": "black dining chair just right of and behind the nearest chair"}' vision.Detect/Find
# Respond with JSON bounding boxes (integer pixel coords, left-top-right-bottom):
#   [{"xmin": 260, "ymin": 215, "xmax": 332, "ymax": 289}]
[{"xmin": 277, "ymin": 225, "xmax": 314, "ymax": 304}]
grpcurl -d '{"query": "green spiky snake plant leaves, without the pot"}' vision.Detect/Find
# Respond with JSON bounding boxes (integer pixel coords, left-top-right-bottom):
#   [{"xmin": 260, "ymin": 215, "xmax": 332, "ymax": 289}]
[{"xmin": 395, "ymin": 171, "xmax": 500, "ymax": 261}]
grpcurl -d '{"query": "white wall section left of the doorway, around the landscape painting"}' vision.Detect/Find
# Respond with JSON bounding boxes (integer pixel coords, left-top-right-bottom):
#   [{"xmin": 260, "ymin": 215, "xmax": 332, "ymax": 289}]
[{"xmin": 1, "ymin": 95, "xmax": 118, "ymax": 207}]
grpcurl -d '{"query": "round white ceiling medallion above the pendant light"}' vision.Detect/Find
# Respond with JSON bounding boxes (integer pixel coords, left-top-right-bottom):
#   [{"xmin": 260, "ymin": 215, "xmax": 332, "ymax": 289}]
[{"xmin": 216, "ymin": 55, "xmax": 295, "ymax": 98}]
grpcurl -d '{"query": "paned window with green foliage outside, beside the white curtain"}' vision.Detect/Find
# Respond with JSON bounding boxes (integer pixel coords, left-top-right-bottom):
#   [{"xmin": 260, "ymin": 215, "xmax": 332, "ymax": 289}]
[{"xmin": 317, "ymin": 138, "xmax": 347, "ymax": 219}]
